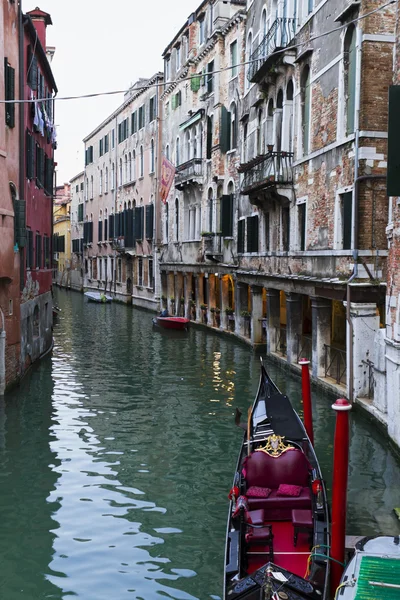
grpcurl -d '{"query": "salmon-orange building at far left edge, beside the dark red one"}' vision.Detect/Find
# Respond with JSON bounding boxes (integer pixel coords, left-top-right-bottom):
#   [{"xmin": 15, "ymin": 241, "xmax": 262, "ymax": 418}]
[{"xmin": 0, "ymin": 2, "xmax": 20, "ymax": 395}]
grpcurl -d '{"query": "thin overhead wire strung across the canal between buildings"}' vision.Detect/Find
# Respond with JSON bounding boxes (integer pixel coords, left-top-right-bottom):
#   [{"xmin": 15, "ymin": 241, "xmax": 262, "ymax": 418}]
[{"xmin": 0, "ymin": 0, "xmax": 396, "ymax": 104}]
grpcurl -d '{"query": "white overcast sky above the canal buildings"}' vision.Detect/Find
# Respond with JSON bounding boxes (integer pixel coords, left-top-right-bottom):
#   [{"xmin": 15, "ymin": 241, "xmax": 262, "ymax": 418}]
[{"xmin": 22, "ymin": 0, "xmax": 201, "ymax": 185}]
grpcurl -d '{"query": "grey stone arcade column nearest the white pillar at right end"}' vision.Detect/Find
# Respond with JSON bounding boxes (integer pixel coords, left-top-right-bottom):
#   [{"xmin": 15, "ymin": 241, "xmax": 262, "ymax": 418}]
[{"xmin": 311, "ymin": 297, "xmax": 332, "ymax": 377}]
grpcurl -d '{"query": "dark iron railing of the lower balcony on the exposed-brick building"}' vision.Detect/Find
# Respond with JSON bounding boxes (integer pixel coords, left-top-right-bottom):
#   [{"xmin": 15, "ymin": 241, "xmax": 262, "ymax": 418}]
[{"xmin": 241, "ymin": 152, "xmax": 293, "ymax": 196}]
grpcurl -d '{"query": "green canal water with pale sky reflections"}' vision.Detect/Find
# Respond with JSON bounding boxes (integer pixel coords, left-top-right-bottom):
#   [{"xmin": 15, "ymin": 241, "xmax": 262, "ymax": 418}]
[{"xmin": 0, "ymin": 290, "xmax": 400, "ymax": 600}]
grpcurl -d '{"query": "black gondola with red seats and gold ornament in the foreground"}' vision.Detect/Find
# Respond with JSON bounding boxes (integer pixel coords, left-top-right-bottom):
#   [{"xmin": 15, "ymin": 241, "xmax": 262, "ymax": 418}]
[{"xmin": 223, "ymin": 363, "xmax": 330, "ymax": 600}]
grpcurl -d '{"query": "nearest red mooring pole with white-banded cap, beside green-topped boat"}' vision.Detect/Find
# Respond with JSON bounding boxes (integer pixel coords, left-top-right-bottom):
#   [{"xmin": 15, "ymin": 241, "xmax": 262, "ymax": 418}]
[{"xmin": 331, "ymin": 398, "xmax": 351, "ymax": 597}]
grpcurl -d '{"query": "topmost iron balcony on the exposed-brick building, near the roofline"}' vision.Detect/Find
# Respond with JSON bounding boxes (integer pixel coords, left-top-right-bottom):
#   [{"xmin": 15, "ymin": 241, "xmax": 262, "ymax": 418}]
[{"xmin": 247, "ymin": 17, "xmax": 296, "ymax": 83}]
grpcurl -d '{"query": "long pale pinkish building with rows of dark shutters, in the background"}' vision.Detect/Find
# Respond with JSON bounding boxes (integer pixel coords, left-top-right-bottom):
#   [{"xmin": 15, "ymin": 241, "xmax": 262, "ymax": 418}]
[{"xmin": 83, "ymin": 73, "xmax": 162, "ymax": 309}]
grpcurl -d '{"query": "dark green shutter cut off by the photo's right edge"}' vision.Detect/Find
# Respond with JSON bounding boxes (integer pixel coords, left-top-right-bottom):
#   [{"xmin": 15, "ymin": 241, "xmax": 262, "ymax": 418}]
[{"xmin": 387, "ymin": 85, "xmax": 400, "ymax": 196}]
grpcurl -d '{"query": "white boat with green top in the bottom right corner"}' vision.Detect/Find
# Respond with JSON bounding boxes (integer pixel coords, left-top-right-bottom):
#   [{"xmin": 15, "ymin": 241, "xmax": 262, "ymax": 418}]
[{"xmin": 335, "ymin": 535, "xmax": 400, "ymax": 600}]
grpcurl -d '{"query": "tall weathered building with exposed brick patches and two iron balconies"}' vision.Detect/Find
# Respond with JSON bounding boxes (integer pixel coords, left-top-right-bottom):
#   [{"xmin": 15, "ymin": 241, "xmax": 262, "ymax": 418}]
[{"xmin": 228, "ymin": 0, "xmax": 394, "ymax": 399}]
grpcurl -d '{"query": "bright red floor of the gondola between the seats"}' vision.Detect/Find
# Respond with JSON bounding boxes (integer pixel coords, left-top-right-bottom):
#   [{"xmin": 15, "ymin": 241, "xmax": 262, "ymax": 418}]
[{"xmin": 247, "ymin": 521, "xmax": 310, "ymax": 577}]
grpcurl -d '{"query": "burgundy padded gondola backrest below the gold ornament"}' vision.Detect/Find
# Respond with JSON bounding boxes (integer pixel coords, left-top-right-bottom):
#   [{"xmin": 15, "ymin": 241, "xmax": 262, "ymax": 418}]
[{"xmin": 244, "ymin": 448, "xmax": 310, "ymax": 489}]
